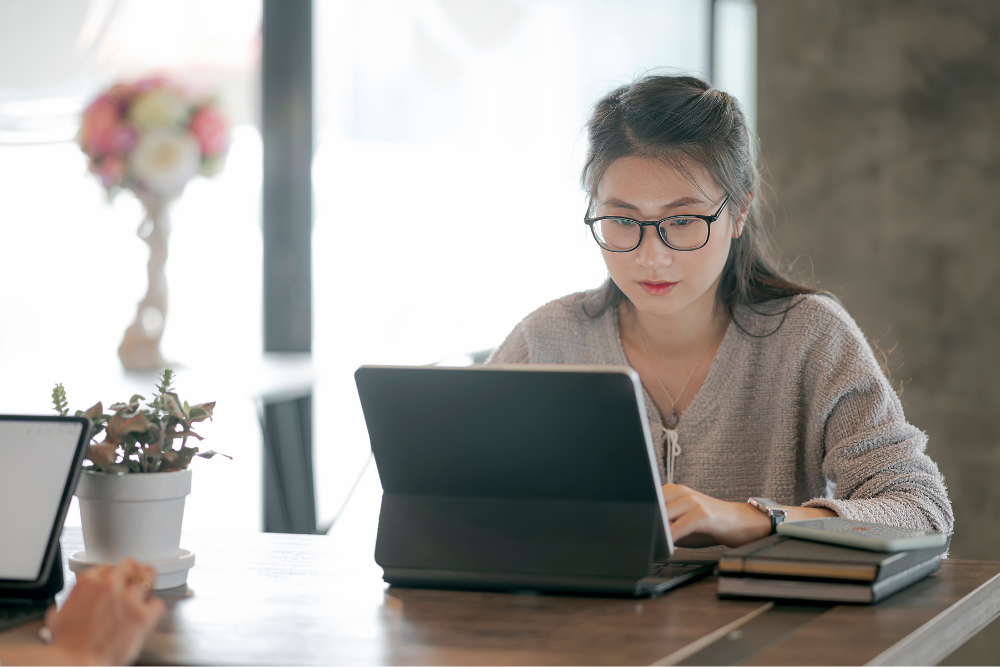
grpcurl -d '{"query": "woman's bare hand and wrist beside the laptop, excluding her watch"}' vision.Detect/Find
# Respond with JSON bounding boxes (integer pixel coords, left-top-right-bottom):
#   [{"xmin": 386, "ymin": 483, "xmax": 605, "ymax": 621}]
[{"xmin": 663, "ymin": 484, "xmax": 837, "ymax": 548}]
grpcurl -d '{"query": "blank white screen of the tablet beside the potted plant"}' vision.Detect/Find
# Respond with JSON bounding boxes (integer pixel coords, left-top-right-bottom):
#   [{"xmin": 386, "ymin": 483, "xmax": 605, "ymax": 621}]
[{"xmin": 0, "ymin": 420, "xmax": 83, "ymax": 581}]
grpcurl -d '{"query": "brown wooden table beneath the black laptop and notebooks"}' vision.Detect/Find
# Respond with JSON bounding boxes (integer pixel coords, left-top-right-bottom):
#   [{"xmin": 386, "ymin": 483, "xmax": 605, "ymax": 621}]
[{"xmin": 0, "ymin": 466, "xmax": 1000, "ymax": 665}]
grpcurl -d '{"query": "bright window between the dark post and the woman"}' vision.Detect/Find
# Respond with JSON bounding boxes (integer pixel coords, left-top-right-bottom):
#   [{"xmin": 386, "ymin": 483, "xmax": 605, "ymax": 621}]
[{"xmin": 313, "ymin": 0, "xmax": 754, "ymax": 516}]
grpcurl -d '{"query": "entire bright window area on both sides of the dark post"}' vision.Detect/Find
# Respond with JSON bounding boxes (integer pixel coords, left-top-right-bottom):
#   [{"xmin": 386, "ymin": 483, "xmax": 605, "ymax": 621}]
[{"xmin": 0, "ymin": 0, "xmax": 754, "ymax": 530}]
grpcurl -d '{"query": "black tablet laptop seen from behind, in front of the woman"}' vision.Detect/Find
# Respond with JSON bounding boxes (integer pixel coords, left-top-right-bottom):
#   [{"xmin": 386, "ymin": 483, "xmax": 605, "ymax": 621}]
[{"xmin": 354, "ymin": 365, "xmax": 714, "ymax": 596}]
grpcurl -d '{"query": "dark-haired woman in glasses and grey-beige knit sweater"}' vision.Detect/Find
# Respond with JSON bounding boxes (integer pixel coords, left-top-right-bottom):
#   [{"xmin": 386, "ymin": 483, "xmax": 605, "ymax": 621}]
[{"xmin": 488, "ymin": 76, "xmax": 954, "ymax": 546}]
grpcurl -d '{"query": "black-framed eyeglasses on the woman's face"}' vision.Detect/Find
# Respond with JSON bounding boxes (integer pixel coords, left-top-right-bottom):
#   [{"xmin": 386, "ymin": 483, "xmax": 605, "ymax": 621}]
[{"xmin": 583, "ymin": 196, "xmax": 729, "ymax": 252}]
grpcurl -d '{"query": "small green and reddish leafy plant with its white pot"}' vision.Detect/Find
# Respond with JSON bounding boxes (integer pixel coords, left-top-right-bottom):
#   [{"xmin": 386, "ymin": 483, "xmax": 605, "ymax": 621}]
[{"xmin": 52, "ymin": 368, "xmax": 232, "ymax": 568}]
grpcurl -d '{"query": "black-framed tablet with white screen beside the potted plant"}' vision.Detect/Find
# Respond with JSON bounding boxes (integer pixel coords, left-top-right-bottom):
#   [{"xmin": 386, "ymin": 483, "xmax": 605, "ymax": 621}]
[{"xmin": 0, "ymin": 415, "xmax": 90, "ymax": 631}]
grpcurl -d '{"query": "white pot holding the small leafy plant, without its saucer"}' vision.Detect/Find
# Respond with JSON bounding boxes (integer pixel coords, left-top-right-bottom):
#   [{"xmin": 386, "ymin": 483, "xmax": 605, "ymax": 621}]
[{"xmin": 76, "ymin": 470, "xmax": 191, "ymax": 563}]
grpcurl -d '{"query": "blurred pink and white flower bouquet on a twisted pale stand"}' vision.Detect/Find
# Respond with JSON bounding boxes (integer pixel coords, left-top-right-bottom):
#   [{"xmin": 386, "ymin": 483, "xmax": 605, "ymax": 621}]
[{"xmin": 78, "ymin": 77, "xmax": 229, "ymax": 371}]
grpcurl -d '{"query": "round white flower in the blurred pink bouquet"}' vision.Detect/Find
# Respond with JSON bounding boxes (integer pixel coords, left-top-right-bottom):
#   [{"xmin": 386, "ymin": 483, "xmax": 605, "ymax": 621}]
[{"xmin": 129, "ymin": 130, "xmax": 201, "ymax": 196}]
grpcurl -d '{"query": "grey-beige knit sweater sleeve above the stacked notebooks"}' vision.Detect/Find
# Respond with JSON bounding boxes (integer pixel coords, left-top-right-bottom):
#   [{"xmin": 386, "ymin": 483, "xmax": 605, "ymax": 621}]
[{"xmin": 805, "ymin": 297, "xmax": 954, "ymax": 533}]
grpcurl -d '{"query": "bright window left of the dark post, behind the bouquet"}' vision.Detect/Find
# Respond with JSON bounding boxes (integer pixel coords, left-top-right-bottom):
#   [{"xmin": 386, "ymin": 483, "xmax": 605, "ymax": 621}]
[{"xmin": 0, "ymin": 0, "xmax": 261, "ymax": 531}]
